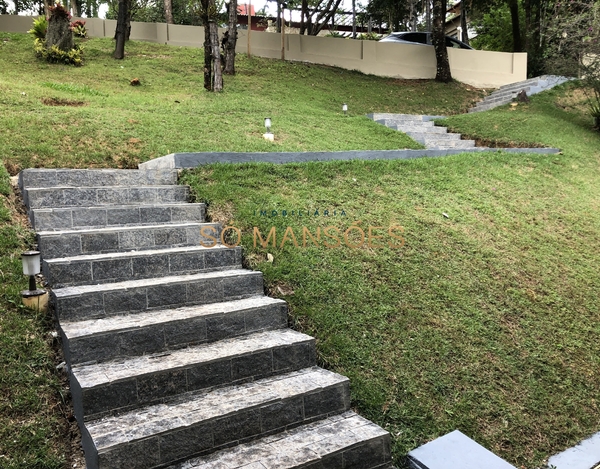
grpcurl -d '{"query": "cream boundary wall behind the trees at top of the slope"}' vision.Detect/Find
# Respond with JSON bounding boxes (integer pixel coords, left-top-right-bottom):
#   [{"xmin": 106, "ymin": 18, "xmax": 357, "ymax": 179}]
[{"xmin": 0, "ymin": 15, "xmax": 527, "ymax": 88}]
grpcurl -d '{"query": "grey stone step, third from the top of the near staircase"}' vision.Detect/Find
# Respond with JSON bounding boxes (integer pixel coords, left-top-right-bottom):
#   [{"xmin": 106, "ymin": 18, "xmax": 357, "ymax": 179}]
[{"xmin": 30, "ymin": 204, "xmax": 206, "ymax": 231}]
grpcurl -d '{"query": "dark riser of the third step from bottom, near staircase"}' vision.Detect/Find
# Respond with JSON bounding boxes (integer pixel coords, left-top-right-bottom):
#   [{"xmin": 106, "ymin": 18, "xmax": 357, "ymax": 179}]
[{"xmin": 71, "ymin": 332, "xmax": 316, "ymax": 420}]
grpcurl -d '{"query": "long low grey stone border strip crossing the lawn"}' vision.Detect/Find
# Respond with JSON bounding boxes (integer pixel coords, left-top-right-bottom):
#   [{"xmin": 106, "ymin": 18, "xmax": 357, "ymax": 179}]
[{"xmin": 139, "ymin": 147, "xmax": 560, "ymax": 170}]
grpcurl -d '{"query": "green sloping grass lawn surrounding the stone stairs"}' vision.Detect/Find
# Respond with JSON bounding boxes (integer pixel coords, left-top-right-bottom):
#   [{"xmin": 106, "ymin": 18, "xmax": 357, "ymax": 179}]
[{"xmin": 0, "ymin": 33, "xmax": 600, "ymax": 469}]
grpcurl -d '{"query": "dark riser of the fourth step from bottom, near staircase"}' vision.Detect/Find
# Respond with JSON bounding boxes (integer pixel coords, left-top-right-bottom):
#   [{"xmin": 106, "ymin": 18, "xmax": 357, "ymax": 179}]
[{"xmin": 61, "ymin": 302, "xmax": 287, "ymax": 366}]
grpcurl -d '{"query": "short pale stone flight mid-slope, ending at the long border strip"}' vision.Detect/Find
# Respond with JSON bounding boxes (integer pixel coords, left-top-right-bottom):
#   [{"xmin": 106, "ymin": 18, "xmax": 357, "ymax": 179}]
[{"xmin": 367, "ymin": 113, "xmax": 475, "ymax": 150}]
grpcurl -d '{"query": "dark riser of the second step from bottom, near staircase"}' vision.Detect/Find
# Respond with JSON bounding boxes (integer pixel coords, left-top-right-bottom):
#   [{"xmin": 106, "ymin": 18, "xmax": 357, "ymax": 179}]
[{"xmin": 82, "ymin": 372, "xmax": 350, "ymax": 469}]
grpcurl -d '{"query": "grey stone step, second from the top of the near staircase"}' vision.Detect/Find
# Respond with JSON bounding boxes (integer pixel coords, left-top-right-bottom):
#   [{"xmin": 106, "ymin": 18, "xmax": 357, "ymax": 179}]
[{"xmin": 23, "ymin": 185, "xmax": 190, "ymax": 210}]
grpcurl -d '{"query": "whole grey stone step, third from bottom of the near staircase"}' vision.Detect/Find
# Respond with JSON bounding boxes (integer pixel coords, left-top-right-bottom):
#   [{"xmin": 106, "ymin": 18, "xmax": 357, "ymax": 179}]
[{"xmin": 71, "ymin": 329, "xmax": 316, "ymax": 420}]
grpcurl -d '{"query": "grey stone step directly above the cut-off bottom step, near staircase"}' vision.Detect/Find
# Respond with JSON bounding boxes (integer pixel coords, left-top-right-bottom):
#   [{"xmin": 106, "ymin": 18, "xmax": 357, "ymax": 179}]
[{"xmin": 82, "ymin": 367, "xmax": 350, "ymax": 469}]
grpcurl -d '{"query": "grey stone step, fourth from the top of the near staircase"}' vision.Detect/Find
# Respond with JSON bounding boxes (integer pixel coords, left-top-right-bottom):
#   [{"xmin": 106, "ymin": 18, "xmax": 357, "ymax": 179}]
[{"xmin": 37, "ymin": 223, "xmax": 221, "ymax": 259}]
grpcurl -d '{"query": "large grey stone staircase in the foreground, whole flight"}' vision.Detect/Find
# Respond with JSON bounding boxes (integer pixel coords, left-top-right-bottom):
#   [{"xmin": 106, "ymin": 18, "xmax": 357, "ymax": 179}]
[{"xmin": 19, "ymin": 169, "xmax": 392, "ymax": 469}]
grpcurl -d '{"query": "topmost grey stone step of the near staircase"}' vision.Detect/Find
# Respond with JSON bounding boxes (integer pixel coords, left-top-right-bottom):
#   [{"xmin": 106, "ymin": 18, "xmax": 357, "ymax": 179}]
[{"xmin": 19, "ymin": 168, "xmax": 177, "ymax": 190}]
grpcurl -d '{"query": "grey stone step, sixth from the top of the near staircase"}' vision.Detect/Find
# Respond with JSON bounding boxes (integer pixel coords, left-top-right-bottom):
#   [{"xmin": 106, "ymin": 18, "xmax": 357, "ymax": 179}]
[{"xmin": 50, "ymin": 269, "xmax": 263, "ymax": 322}]
